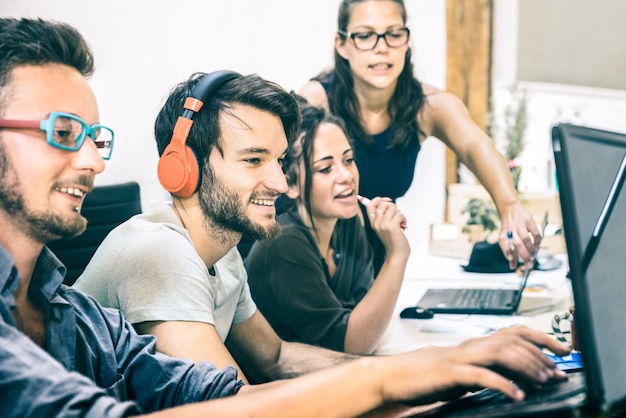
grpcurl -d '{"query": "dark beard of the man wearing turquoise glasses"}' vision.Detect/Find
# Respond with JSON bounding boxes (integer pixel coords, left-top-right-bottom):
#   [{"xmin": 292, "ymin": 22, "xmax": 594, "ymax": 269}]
[{"xmin": 0, "ymin": 143, "xmax": 87, "ymax": 244}]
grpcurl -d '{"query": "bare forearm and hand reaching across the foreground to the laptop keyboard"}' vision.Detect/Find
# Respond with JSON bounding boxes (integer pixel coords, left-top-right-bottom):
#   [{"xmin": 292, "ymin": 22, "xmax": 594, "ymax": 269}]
[{"xmin": 151, "ymin": 327, "xmax": 569, "ymax": 418}]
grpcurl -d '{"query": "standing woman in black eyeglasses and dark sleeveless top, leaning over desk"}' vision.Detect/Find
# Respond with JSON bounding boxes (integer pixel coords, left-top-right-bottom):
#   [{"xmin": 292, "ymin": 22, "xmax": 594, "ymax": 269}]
[{"xmin": 299, "ymin": 0, "xmax": 541, "ymax": 269}]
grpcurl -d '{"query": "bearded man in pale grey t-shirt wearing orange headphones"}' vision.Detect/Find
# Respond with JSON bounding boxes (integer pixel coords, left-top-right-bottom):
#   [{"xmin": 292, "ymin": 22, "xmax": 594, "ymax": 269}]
[{"xmin": 74, "ymin": 71, "xmax": 354, "ymax": 382}]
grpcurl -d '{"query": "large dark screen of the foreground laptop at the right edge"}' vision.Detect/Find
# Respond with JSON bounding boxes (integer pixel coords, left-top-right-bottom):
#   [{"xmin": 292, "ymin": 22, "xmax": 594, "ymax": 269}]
[{"xmin": 552, "ymin": 124, "xmax": 626, "ymax": 409}]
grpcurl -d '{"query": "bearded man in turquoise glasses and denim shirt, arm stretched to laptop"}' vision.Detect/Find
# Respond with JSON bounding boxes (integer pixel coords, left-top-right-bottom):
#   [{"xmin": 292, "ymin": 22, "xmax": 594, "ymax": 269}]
[{"xmin": 0, "ymin": 18, "xmax": 568, "ymax": 418}]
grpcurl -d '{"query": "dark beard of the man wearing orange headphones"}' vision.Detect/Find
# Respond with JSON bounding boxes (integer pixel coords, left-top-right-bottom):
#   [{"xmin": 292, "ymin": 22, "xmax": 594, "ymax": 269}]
[{"xmin": 200, "ymin": 164, "xmax": 280, "ymax": 240}]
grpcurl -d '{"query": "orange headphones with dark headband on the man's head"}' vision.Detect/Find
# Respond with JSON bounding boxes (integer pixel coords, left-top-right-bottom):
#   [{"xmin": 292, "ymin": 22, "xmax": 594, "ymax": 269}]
[{"xmin": 157, "ymin": 70, "xmax": 241, "ymax": 198}]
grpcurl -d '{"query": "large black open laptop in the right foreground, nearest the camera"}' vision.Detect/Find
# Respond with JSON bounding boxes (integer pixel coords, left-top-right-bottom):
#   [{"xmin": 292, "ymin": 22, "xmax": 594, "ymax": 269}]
[{"xmin": 408, "ymin": 124, "xmax": 626, "ymax": 417}]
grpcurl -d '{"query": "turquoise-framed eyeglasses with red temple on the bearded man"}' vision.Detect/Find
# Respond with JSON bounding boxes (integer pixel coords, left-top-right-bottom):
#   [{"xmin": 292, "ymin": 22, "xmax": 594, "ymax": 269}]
[{"xmin": 0, "ymin": 112, "xmax": 115, "ymax": 160}]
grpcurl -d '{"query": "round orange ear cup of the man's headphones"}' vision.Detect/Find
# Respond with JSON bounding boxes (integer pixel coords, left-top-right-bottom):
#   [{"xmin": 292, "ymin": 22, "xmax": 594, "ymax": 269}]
[{"xmin": 157, "ymin": 141, "xmax": 200, "ymax": 198}]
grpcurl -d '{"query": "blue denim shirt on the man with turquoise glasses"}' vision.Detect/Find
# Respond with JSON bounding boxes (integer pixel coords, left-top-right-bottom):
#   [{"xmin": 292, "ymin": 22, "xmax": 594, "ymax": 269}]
[{"xmin": 0, "ymin": 246, "xmax": 243, "ymax": 418}]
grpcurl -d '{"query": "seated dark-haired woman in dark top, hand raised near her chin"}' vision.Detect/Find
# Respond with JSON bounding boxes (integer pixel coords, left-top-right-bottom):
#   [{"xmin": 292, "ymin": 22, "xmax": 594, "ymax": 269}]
[{"xmin": 241, "ymin": 99, "xmax": 410, "ymax": 354}]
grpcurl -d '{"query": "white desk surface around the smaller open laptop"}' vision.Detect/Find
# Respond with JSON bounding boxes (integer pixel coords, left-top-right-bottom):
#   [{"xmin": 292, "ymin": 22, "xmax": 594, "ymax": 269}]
[{"xmin": 375, "ymin": 249, "xmax": 572, "ymax": 355}]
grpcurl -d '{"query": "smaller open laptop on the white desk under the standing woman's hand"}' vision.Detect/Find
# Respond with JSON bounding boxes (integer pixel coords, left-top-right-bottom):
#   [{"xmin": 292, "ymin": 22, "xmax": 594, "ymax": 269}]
[{"xmin": 417, "ymin": 213, "xmax": 548, "ymax": 315}]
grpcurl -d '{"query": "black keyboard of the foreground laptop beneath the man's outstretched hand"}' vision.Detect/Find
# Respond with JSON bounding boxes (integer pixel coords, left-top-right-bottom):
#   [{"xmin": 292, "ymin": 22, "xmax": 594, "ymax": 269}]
[{"xmin": 420, "ymin": 373, "xmax": 586, "ymax": 417}]
